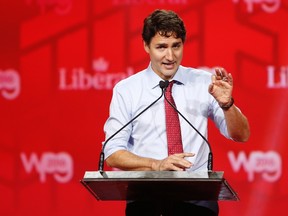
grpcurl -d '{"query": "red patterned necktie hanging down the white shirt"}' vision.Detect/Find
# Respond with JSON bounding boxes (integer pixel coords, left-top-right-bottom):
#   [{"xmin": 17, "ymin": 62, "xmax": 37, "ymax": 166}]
[{"xmin": 165, "ymin": 81, "xmax": 183, "ymax": 155}]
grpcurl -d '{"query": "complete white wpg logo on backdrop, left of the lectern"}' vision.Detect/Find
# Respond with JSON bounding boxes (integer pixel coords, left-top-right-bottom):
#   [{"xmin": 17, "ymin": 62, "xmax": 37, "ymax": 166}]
[{"xmin": 20, "ymin": 152, "xmax": 73, "ymax": 183}]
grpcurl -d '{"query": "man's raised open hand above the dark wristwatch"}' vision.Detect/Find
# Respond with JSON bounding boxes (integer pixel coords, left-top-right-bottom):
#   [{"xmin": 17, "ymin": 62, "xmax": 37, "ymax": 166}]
[{"xmin": 208, "ymin": 68, "xmax": 233, "ymax": 106}]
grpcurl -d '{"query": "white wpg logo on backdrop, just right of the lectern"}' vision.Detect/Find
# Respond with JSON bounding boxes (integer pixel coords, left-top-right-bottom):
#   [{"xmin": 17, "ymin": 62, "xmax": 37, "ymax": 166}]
[{"xmin": 228, "ymin": 151, "xmax": 282, "ymax": 182}]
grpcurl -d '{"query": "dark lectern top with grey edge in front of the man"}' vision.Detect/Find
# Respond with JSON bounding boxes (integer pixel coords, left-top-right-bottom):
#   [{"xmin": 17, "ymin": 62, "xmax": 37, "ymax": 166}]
[{"xmin": 80, "ymin": 171, "xmax": 239, "ymax": 201}]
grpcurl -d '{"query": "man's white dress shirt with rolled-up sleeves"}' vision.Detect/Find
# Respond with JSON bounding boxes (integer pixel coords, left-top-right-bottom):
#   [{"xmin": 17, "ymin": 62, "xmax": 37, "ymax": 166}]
[{"xmin": 104, "ymin": 65, "xmax": 230, "ymax": 170}]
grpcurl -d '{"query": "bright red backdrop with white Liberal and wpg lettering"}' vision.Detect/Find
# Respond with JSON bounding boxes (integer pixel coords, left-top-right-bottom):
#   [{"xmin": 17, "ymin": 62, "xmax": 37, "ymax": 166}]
[{"xmin": 0, "ymin": 0, "xmax": 288, "ymax": 216}]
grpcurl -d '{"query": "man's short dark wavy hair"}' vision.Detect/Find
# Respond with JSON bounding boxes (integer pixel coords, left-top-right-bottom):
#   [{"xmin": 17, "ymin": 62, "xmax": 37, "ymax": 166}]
[{"xmin": 142, "ymin": 9, "xmax": 186, "ymax": 45}]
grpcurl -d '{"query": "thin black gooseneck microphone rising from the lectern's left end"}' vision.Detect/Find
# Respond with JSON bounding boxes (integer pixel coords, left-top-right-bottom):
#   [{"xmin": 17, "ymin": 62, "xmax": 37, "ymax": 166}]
[{"xmin": 98, "ymin": 80, "xmax": 169, "ymax": 174}]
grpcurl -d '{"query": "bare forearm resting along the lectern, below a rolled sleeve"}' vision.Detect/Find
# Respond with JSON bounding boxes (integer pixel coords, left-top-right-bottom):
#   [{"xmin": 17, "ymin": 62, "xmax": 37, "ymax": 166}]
[{"xmin": 106, "ymin": 150, "xmax": 159, "ymax": 171}]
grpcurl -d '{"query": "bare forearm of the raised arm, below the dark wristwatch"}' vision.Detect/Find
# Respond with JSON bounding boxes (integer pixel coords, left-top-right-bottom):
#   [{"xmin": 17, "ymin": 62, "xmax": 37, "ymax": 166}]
[{"xmin": 223, "ymin": 105, "xmax": 250, "ymax": 142}]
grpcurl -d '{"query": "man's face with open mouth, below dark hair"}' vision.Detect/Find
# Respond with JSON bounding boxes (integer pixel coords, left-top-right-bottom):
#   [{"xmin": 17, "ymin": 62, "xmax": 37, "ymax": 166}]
[{"xmin": 144, "ymin": 34, "xmax": 183, "ymax": 80}]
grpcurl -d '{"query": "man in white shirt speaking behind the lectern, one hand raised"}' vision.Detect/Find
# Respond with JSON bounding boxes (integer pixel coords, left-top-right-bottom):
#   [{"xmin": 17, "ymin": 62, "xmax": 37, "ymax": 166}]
[{"xmin": 104, "ymin": 10, "xmax": 250, "ymax": 216}]
